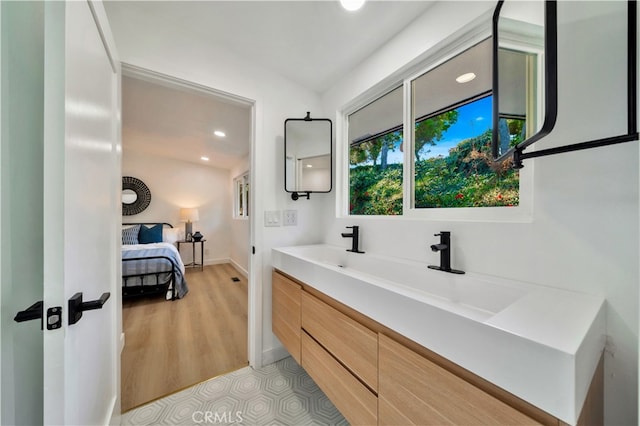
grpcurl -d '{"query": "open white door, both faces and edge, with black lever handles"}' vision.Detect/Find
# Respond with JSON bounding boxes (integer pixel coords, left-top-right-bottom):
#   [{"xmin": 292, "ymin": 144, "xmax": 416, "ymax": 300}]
[{"xmin": 0, "ymin": 1, "xmax": 121, "ymax": 425}]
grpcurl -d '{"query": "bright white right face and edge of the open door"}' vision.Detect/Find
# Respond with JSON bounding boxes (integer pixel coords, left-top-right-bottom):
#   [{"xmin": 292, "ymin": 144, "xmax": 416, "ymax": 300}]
[{"xmin": 43, "ymin": 1, "xmax": 121, "ymax": 425}]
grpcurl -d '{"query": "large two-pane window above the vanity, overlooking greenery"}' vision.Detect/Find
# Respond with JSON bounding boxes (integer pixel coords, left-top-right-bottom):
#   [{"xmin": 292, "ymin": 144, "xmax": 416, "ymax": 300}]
[{"xmin": 347, "ymin": 39, "xmax": 536, "ymax": 215}]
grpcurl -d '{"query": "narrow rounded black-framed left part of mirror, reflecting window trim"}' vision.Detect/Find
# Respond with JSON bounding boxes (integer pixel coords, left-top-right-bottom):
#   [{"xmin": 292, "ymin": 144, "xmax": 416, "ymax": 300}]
[{"xmin": 492, "ymin": 0, "xmax": 558, "ymax": 161}]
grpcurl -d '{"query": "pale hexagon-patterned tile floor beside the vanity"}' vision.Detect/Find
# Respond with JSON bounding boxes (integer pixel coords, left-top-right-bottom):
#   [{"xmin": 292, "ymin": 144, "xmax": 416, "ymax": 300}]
[{"xmin": 122, "ymin": 357, "xmax": 348, "ymax": 426}]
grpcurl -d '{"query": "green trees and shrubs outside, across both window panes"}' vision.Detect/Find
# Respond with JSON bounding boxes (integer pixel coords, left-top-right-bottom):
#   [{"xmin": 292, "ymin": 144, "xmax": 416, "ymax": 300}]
[{"xmin": 349, "ymin": 97, "xmax": 525, "ymax": 215}]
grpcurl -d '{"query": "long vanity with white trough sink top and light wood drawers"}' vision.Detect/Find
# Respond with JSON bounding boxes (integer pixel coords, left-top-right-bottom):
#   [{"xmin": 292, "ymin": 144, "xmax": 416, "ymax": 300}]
[{"xmin": 272, "ymin": 245, "xmax": 604, "ymax": 425}]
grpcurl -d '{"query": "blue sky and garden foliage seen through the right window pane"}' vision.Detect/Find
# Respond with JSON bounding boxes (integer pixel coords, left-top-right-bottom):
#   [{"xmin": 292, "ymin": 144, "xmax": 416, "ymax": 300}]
[{"xmin": 414, "ymin": 95, "xmax": 519, "ymax": 208}]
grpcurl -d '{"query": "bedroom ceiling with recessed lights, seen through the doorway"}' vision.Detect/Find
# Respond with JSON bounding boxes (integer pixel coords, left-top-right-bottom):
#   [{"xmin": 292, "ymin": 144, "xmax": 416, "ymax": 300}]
[{"xmin": 122, "ymin": 75, "xmax": 251, "ymax": 169}]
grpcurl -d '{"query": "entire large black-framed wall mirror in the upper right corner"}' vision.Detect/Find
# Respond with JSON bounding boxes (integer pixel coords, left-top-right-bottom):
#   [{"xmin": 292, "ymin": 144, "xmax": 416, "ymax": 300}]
[{"xmin": 492, "ymin": 0, "xmax": 638, "ymax": 168}]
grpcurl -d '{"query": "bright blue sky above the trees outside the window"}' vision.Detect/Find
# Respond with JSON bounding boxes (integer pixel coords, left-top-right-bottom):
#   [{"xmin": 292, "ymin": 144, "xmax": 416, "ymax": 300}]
[{"xmin": 388, "ymin": 96, "xmax": 492, "ymax": 163}]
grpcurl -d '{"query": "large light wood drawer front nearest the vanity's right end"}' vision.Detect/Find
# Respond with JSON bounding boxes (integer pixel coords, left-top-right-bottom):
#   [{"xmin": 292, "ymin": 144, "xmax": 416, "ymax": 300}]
[{"xmin": 378, "ymin": 334, "xmax": 539, "ymax": 425}]
